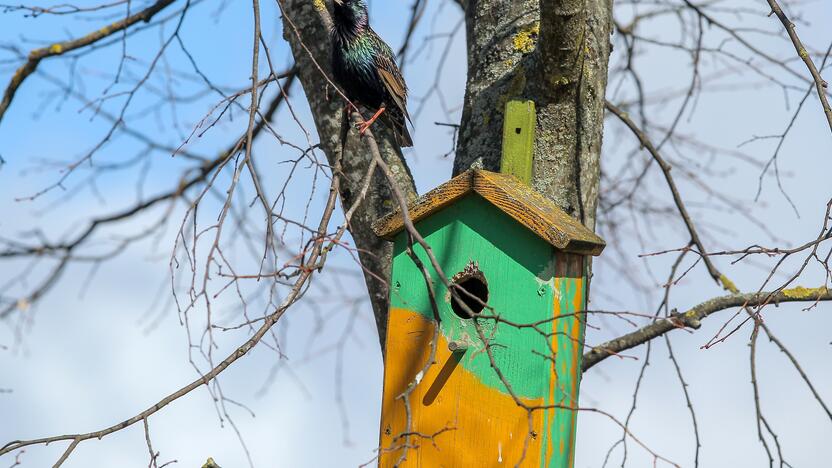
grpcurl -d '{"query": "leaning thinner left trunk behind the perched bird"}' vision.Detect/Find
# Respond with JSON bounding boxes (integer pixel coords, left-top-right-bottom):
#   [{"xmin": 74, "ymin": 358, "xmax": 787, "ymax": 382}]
[{"xmin": 283, "ymin": 0, "xmax": 416, "ymax": 349}]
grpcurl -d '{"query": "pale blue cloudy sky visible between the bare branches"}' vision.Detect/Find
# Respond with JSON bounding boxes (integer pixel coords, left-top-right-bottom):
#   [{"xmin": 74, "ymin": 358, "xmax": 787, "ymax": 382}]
[{"xmin": 0, "ymin": 1, "xmax": 832, "ymax": 468}]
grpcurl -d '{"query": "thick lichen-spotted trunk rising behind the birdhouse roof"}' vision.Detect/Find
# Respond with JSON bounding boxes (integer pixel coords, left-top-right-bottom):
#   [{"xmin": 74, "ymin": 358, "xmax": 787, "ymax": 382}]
[{"xmin": 454, "ymin": 0, "xmax": 612, "ymax": 229}]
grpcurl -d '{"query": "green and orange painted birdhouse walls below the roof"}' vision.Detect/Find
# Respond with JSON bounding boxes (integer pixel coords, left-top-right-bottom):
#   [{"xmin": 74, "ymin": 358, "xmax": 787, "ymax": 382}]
[{"xmin": 379, "ymin": 199, "xmax": 586, "ymax": 468}]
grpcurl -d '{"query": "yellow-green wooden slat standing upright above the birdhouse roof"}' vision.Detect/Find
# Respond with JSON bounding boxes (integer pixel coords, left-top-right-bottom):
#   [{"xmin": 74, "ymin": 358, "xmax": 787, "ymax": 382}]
[{"xmin": 500, "ymin": 101, "xmax": 537, "ymax": 185}]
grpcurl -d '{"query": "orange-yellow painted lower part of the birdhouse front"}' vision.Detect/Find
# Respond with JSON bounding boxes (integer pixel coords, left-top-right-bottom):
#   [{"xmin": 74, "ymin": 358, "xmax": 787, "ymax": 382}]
[{"xmin": 379, "ymin": 308, "xmax": 545, "ymax": 468}]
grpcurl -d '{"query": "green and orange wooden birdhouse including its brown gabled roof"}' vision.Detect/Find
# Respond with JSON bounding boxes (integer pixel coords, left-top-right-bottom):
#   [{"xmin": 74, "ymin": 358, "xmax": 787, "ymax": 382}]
[{"xmin": 374, "ymin": 167, "xmax": 605, "ymax": 467}]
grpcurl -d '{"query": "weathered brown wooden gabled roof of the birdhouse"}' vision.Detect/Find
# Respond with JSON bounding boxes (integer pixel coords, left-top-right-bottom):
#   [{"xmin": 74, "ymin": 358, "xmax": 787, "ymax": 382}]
[{"xmin": 373, "ymin": 170, "xmax": 606, "ymax": 255}]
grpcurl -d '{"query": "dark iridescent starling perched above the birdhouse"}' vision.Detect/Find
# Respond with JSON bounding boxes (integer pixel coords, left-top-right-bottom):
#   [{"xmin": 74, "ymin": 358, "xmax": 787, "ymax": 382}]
[{"xmin": 331, "ymin": 0, "xmax": 413, "ymax": 147}]
